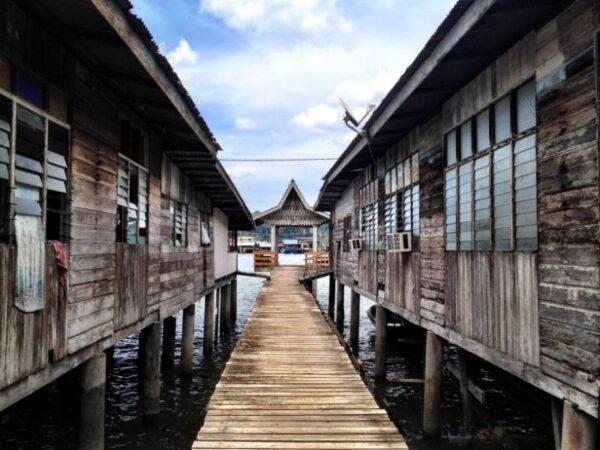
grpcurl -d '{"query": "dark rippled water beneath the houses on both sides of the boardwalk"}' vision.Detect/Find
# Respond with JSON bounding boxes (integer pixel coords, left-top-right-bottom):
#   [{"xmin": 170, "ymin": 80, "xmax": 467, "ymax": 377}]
[{"xmin": 0, "ymin": 255, "xmax": 552, "ymax": 450}]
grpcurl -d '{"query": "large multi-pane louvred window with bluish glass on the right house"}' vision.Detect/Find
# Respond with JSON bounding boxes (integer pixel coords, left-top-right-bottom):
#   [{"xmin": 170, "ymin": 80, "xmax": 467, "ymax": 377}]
[{"xmin": 444, "ymin": 81, "xmax": 537, "ymax": 251}]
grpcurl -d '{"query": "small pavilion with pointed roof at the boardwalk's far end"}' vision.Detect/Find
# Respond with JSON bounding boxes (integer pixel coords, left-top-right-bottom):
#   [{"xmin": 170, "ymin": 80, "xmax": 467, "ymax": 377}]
[{"xmin": 254, "ymin": 180, "xmax": 329, "ymax": 252}]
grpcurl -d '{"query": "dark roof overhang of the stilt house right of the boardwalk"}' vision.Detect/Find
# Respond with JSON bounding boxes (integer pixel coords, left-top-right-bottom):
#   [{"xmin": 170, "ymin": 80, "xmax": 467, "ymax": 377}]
[{"xmin": 315, "ymin": 0, "xmax": 573, "ymax": 211}]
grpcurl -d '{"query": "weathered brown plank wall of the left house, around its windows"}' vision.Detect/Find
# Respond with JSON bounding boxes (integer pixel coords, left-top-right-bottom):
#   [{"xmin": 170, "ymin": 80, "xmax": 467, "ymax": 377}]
[{"xmin": 0, "ymin": 1, "xmax": 223, "ymax": 408}]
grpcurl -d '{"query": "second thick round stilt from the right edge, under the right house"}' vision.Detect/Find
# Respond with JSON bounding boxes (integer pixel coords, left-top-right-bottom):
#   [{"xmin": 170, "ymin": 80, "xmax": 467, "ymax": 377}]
[{"xmin": 423, "ymin": 331, "xmax": 442, "ymax": 436}]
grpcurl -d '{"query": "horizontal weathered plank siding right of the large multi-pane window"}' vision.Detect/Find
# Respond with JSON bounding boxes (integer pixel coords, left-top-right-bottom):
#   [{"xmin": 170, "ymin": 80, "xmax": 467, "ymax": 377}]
[{"xmin": 536, "ymin": 0, "xmax": 600, "ymax": 398}]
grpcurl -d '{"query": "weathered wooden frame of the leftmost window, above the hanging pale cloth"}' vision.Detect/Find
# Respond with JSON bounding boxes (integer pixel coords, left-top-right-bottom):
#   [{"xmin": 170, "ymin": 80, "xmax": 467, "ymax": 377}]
[{"xmin": 0, "ymin": 88, "xmax": 72, "ymax": 244}]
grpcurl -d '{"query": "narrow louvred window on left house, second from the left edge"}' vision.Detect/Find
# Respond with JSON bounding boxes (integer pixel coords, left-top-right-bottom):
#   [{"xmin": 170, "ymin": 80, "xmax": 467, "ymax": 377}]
[{"xmin": 117, "ymin": 155, "xmax": 148, "ymax": 245}]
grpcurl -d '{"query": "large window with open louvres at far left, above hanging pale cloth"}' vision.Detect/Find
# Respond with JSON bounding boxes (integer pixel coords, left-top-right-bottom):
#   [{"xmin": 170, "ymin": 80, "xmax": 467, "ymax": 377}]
[{"xmin": 0, "ymin": 95, "xmax": 70, "ymax": 242}]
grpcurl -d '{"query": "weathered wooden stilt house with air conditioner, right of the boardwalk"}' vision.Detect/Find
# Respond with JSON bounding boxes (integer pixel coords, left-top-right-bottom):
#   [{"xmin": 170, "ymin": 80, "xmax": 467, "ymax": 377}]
[{"xmin": 316, "ymin": 0, "xmax": 600, "ymax": 436}]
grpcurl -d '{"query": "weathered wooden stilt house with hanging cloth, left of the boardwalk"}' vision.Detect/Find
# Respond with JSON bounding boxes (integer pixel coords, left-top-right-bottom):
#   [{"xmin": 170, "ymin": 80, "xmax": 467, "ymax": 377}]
[{"xmin": 0, "ymin": 0, "xmax": 253, "ymax": 410}]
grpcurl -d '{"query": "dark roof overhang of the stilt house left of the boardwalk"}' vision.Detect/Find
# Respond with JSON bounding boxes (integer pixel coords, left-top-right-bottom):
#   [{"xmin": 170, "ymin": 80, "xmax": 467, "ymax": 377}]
[{"xmin": 19, "ymin": 0, "xmax": 254, "ymax": 229}]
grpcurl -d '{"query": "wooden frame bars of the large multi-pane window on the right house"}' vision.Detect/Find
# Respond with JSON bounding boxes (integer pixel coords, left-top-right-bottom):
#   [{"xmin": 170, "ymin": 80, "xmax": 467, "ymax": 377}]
[{"xmin": 443, "ymin": 77, "xmax": 539, "ymax": 253}]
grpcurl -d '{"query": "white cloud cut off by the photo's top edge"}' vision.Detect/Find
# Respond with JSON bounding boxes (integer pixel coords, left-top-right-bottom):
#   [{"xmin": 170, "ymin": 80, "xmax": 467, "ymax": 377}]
[{"xmin": 200, "ymin": 0, "xmax": 352, "ymax": 33}]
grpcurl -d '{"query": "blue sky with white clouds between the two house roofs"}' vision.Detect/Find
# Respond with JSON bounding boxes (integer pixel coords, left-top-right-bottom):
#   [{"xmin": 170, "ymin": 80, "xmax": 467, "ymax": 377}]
[{"xmin": 133, "ymin": 0, "xmax": 455, "ymax": 211}]
